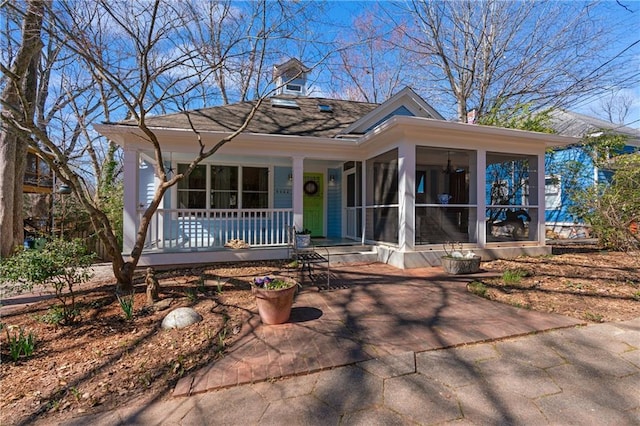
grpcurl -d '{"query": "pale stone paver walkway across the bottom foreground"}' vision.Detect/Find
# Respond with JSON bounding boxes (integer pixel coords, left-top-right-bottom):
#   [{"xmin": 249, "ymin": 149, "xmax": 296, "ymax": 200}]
[{"xmin": 65, "ymin": 318, "xmax": 640, "ymax": 426}]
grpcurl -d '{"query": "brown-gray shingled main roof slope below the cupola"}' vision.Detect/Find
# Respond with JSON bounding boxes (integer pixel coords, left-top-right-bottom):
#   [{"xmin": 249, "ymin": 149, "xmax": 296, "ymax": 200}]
[{"xmin": 119, "ymin": 97, "xmax": 378, "ymax": 137}]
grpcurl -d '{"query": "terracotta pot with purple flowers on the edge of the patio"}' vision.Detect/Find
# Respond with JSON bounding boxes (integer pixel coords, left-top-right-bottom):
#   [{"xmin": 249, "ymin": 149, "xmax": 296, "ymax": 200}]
[{"xmin": 251, "ymin": 277, "xmax": 298, "ymax": 324}]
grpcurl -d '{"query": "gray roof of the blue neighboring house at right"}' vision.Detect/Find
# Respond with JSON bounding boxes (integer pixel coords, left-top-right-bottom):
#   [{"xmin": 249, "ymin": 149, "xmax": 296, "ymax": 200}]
[{"xmin": 551, "ymin": 110, "xmax": 640, "ymax": 140}]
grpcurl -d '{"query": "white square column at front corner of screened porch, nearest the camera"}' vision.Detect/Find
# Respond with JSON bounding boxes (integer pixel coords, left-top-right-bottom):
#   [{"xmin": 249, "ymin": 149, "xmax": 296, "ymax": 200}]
[{"xmin": 398, "ymin": 143, "xmax": 416, "ymax": 251}]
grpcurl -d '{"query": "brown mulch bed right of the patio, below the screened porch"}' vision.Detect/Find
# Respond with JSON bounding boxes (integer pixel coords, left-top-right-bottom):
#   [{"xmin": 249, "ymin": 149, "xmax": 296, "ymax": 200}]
[{"xmin": 480, "ymin": 245, "xmax": 640, "ymax": 322}]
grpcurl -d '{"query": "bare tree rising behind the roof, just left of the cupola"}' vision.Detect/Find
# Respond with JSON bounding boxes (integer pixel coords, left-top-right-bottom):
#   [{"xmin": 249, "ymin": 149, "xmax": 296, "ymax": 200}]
[{"xmin": 168, "ymin": 0, "xmax": 317, "ymax": 109}]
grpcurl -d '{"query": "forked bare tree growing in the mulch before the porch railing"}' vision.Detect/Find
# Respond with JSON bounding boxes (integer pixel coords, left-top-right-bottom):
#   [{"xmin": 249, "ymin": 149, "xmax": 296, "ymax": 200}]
[{"xmin": 3, "ymin": 0, "xmax": 322, "ymax": 290}]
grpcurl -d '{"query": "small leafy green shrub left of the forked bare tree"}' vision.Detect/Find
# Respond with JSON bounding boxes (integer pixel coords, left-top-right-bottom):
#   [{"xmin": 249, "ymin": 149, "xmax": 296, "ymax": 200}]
[{"xmin": 0, "ymin": 239, "xmax": 94, "ymax": 324}]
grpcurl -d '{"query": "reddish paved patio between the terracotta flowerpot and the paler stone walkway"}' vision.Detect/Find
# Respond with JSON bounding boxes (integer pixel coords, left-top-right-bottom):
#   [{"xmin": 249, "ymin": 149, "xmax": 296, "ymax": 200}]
[{"xmin": 173, "ymin": 263, "xmax": 579, "ymax": 396}]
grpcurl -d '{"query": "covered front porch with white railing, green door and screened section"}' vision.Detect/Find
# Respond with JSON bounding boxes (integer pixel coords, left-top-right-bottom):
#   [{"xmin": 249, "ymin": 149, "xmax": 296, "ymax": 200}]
[{"xmin": 116, "ymin": 117, "xmax": 567, "ymax": 268}]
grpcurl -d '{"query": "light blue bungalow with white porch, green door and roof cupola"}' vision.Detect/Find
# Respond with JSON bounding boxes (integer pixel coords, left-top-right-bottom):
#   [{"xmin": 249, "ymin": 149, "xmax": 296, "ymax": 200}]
[{"xmin": 95, "ymin": 60, "xmax": 576, "ymax": 268}]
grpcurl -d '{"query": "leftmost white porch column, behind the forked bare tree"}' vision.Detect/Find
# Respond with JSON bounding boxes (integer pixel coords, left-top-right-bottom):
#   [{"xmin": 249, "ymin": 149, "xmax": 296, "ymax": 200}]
[{"xmin": 122, "ymin": 148, "xmax": 139, "ymax": 254}]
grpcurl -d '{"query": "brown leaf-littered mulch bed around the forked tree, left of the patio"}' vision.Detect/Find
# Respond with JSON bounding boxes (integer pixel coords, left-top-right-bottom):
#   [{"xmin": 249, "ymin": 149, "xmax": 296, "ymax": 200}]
[{"xmin": 0, "ymin": 263, "xmax": 281, "ymax": 425}]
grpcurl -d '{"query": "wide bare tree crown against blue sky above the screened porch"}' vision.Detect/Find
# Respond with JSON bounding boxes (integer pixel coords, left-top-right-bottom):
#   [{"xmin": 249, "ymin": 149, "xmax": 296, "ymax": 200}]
[{"xmin": 398, "ymin": 0, "xmax": 638, "ymax": 122}]
